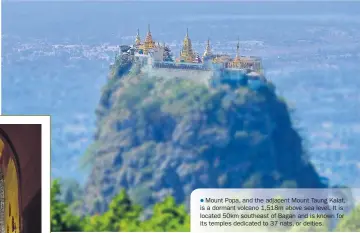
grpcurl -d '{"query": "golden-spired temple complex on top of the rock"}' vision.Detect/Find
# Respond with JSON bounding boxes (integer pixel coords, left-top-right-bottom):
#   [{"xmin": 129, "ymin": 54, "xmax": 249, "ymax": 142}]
[{"xmin": 116, "ymin": 25, "xmax": 263, "ymax": 77}]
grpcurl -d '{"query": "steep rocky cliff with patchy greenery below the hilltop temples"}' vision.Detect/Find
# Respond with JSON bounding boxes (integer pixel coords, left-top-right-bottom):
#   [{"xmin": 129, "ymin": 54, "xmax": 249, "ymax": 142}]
[{"xmin": 83, "ymin": 60, "xmax": 322, "ymax": 213}]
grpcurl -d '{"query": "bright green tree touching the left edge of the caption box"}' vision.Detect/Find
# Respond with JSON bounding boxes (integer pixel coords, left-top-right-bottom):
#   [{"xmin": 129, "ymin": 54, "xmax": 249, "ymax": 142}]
[{"xmin": 142, "ymin": 197, "xmax": 190, "ymax": 232}]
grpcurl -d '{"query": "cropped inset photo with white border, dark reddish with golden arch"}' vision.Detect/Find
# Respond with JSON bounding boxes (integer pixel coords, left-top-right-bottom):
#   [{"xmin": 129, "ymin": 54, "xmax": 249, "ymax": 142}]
[{"xmin": 0, "ymin": 116, "xmax": 50, "ymax": 233}]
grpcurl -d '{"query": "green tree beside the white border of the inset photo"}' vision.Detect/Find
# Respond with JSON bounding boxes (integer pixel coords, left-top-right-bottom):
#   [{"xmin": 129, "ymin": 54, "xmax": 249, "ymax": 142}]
[{"xmin": 50, "ymin": 180, "xmax": 82, "ymax": 232}]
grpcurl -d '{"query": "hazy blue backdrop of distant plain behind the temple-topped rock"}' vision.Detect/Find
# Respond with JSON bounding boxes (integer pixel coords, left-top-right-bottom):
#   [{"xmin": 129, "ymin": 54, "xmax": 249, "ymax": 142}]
[{"xmin": 2, "ymin": 2, "xmax": 360, "ymax": 186}]
